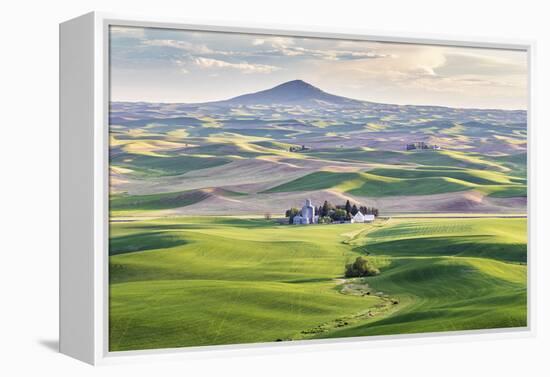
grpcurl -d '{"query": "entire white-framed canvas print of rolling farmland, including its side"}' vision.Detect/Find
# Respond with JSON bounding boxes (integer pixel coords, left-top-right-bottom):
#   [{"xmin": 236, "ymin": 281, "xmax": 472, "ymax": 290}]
[{"xmin": 60, "ymin": 13, "xmax": 531, "ymax": 363}]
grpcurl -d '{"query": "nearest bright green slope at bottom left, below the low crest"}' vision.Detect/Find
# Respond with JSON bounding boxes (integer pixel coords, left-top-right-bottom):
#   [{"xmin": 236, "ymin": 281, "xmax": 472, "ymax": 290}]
[{"xmin": 110, "ymin": 280, "xmax": 378, "ymax": 350}]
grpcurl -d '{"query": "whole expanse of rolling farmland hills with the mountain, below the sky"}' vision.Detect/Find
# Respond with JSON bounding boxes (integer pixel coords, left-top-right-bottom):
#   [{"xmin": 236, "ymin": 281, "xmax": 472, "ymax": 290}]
[{"xmin": 109, "ymin": 80, "xmax": 528, "ymax": 351}]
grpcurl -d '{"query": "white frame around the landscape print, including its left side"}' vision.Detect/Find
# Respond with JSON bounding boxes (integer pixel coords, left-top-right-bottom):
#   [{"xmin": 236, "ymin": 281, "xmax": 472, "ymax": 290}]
[{"xmin": 60, "ymin": 12, "xmax": 536, "ymax": 364}]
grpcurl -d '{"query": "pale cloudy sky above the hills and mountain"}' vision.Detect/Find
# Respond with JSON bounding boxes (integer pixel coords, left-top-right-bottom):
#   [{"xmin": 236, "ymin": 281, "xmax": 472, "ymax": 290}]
[{"xmin": 110, "ymin": 26, "xmax": 528, "ymax": 109}]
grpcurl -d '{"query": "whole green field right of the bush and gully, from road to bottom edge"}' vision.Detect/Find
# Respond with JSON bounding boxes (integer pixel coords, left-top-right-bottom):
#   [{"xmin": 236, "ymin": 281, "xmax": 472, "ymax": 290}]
[{"xmin": 329, "ymin": 219, "xmax": 527, "ymax": 337}]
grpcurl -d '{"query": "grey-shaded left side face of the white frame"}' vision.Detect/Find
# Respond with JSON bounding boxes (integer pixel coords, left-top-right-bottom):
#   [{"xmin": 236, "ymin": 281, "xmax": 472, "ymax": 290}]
[{"xmin": 59, "ymin": 14, "xmax": 97, "ymax": 363}]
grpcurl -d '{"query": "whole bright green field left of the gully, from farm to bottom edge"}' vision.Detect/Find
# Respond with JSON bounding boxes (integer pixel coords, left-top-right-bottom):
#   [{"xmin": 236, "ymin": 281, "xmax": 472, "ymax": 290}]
[{"xmin": 111, "ymin": 218, "xmax": 379, "ymax": 350}]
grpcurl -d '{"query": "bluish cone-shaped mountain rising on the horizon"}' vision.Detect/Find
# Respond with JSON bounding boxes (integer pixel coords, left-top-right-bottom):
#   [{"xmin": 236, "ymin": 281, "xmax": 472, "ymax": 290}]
[{"xmin": 208, "ymin": 80, "xmax": 368, "ymax": 107}]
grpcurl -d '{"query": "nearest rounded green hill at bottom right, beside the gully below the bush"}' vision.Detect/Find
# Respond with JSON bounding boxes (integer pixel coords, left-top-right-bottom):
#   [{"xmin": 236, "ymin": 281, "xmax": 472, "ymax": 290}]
[{"xmin": 327, "ymin": 257, "xmax": 527, "ymax": 337}]
